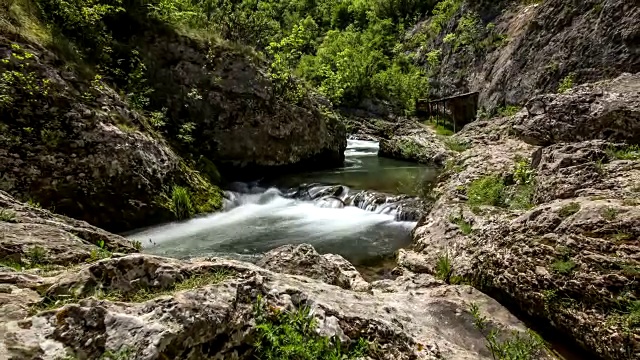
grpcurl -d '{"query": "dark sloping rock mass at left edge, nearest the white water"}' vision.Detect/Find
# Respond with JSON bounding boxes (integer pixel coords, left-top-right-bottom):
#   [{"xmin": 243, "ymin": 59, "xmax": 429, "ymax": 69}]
[{"xmin": 0, "ymin": 36, "xmax": 215, "ymax": 231}]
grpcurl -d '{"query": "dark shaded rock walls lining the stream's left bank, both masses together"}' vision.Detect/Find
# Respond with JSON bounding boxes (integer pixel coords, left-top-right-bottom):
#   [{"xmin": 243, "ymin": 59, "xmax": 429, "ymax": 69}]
[{"xmin": 0, "ymin": 5, "xmax": 346, "ymax": 231}]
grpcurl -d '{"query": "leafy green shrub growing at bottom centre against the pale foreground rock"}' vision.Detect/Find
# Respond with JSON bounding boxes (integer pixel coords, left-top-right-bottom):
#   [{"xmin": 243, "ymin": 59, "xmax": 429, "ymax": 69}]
[{"xmin": 253, "ymin": 298, "xmax": 369, "ymax": 360}]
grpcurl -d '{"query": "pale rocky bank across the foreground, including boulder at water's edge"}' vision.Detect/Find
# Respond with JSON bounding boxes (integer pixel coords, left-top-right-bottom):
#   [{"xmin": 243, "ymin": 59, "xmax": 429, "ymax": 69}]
[{"xmin": 0, "ymin": 197, "xmax": 544, "ymax": 360}]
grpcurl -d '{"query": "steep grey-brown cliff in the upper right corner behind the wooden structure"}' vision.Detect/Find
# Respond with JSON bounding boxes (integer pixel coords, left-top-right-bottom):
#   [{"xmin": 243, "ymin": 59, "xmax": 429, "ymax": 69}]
[{"xmin": 409, "ymin": 0, "xmax": 640, "ymax": 110}]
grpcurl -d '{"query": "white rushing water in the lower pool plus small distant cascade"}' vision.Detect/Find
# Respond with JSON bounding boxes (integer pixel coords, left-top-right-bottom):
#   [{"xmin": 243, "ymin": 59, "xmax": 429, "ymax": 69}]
[{"xmin": 129, "ymin": 140, "xmax": 424, "ymax": 263}]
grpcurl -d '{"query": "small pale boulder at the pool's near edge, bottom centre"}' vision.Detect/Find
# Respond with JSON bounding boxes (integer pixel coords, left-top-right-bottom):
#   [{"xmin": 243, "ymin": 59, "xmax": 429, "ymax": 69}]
[{"xmin": 257, "ymin": 244, "xmax": 371, "ymax": 291}]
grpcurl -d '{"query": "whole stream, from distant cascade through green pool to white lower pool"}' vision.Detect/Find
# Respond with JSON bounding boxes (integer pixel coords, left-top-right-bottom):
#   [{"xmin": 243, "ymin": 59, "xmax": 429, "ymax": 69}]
[{"xmin": 128, "ymin": 140, "xmax": 435, "ymax": 265}]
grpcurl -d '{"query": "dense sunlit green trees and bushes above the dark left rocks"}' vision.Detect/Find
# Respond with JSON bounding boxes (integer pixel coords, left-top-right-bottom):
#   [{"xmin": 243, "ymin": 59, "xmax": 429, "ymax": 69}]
[{"xmin": 30, "ymin": 0, "xmax": 442, "ymax": 110}]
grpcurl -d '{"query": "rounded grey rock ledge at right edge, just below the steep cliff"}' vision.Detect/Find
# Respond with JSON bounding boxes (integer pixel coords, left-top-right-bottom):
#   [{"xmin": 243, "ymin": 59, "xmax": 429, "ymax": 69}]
[{"xmin": 513, "ymin": 74, "xmax": 640, "ymax": 146}]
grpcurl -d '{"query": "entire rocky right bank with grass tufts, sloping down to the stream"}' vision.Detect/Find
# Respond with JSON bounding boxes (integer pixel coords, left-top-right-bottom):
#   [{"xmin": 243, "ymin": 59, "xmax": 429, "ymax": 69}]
[{"xmin": 398, "ymin": 74, "xmax": 640, "ymax": 359}]
